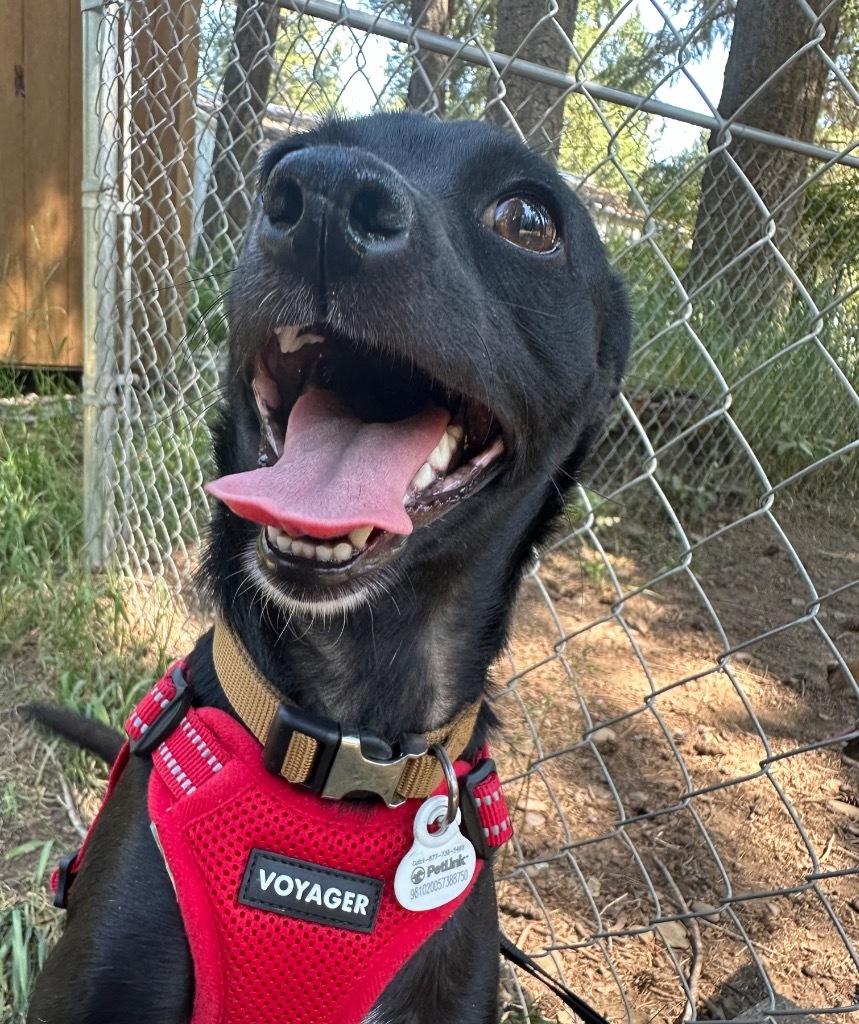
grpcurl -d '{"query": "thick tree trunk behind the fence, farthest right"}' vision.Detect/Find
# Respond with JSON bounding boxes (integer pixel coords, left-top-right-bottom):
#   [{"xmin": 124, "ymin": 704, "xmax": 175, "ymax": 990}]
[{"xmin": 686, "ymin": 0, "xmax": 841, "ymax": 325}]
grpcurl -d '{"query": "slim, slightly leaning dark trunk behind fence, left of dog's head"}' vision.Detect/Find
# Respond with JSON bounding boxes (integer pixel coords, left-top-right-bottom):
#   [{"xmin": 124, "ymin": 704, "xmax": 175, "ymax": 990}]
[{"xmin": 197, "ymin": 0, "xmax": 280, "ymax": 256}]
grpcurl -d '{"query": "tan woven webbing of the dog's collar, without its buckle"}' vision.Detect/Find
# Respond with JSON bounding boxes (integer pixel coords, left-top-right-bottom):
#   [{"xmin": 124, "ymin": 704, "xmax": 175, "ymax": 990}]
[{"xmin": 213, "ymin": 620, "xmax": 482, "ymax": 800}]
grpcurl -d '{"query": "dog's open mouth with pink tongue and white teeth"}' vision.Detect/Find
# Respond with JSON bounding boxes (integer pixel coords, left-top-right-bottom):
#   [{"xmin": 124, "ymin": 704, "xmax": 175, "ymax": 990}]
[{"xmin": 207, "ymin": 326, "xmax": 505, "ymax": 582}]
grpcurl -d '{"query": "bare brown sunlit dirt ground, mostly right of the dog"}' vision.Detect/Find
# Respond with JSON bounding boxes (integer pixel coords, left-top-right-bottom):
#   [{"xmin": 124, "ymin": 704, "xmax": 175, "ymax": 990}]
[{"xmin": 0, "ymin": 499, "xmax": 859, "ymax": 1024}]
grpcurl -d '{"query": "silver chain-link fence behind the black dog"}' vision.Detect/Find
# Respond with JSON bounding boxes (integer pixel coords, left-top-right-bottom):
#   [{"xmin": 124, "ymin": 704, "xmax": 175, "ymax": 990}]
[{"xmin": 84, "ymin": 0, "xmax": 859, "ymax": 1022}]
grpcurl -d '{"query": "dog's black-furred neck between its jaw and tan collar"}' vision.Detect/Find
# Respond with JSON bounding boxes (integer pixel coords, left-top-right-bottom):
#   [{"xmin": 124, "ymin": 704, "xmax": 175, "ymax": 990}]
[{"xmin": 194, "ymin": 471, "xmax": 557, "ymax": 741}]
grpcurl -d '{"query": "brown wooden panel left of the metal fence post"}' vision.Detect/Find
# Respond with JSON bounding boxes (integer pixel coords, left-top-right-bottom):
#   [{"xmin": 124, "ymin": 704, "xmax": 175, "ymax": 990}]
[{"xmin": 0, "ymin": 0, "xmax": 83, "ymax": 368}]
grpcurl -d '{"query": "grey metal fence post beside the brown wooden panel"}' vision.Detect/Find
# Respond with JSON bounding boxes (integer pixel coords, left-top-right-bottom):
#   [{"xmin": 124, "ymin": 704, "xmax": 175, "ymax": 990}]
[{"xmin": 81, "ymin": 0, "xmax": 117, "ymax": 568}]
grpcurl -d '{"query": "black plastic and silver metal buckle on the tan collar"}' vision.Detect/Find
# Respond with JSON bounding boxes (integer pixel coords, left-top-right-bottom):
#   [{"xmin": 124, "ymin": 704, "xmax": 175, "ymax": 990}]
[{"xmin": 263, "ymin": 703, "xmax": 427, "ymax": 807}]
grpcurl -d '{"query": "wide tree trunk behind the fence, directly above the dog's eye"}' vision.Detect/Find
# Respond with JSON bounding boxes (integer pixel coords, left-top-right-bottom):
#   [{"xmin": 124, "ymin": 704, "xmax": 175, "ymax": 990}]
[{"xmin": 489, "ymin": 0, "xmax": 578, "ymax": 160}]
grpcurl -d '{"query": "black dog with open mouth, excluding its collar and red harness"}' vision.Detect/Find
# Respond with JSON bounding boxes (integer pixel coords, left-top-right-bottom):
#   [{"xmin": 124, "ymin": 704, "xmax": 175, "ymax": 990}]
[{"xmin": 29, "ymin": 114, "xmax": 630, "ymax": 1024}]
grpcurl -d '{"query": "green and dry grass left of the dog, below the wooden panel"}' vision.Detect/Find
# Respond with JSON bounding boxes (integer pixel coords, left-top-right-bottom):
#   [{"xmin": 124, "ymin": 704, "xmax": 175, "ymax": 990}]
[{"xmin": 0, "ymin": 371, "xmax": 181, "ymax": 1024}]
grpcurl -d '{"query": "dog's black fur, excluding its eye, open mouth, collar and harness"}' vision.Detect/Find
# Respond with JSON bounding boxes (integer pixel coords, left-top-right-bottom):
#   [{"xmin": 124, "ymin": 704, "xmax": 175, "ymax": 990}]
[{"xmin": 29, "ymin": 114, "xmax": 629, "ymax": 1024}]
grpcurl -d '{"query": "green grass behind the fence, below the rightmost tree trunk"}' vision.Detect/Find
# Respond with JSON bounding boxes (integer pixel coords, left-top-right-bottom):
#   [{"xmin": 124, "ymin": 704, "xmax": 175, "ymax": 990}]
[{"xmin": 602, "ymin": 244, "xmax": 859, "ymax": 506}]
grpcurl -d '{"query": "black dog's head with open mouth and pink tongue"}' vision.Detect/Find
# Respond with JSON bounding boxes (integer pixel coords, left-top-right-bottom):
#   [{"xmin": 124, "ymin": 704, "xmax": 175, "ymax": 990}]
[{"xmin": 209, "ymin": 114, "xmax": 629, "ymax": 614}]
